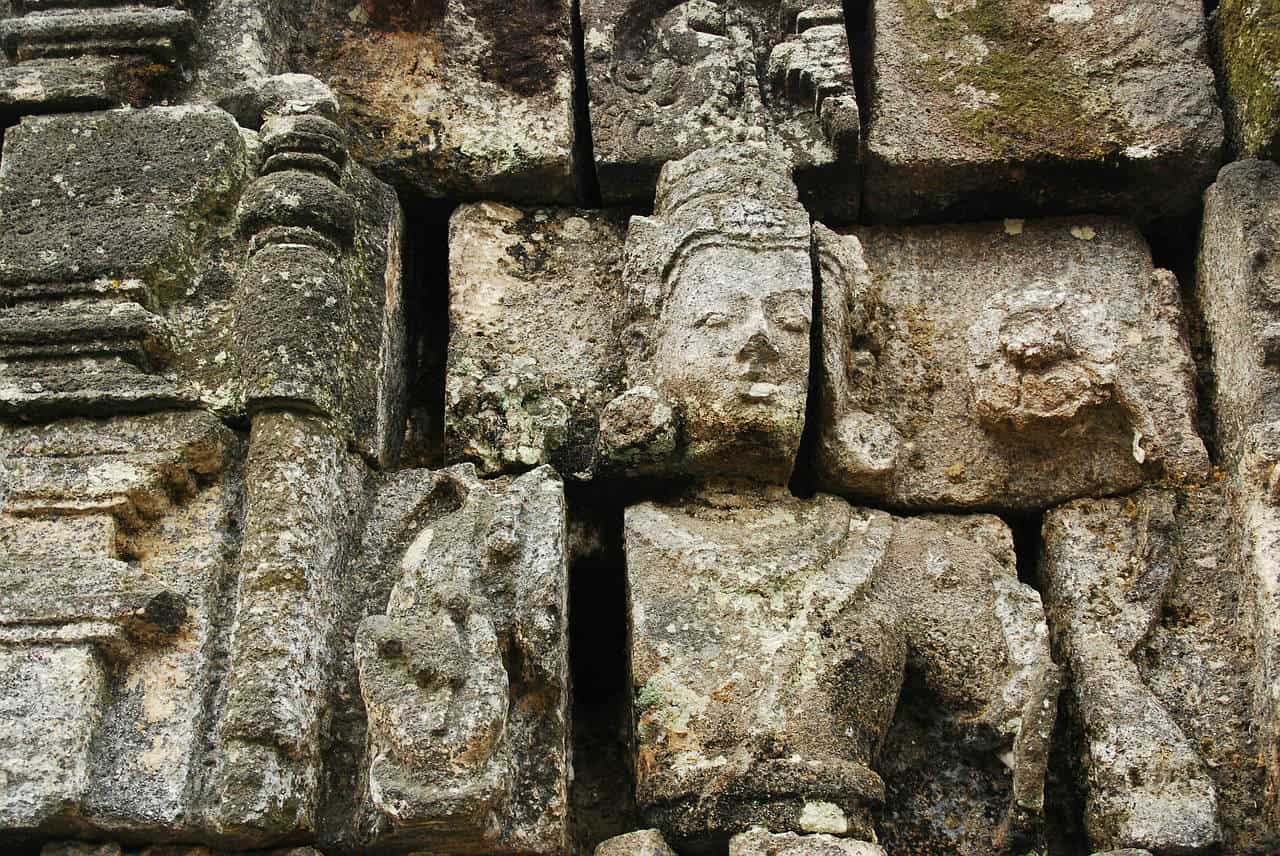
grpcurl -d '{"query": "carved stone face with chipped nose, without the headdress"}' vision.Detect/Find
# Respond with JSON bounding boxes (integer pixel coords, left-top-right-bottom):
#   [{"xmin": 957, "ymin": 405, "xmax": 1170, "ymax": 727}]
[{"xmin": 654, "ymin": 240, "xmax": 813, "ymax": 473}]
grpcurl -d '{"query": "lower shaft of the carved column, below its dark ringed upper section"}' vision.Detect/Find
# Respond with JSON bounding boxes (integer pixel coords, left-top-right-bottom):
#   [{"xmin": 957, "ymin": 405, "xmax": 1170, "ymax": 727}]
[{"xmin": 209, "ymin": 409, "xmax": 364, "ymax": 846}]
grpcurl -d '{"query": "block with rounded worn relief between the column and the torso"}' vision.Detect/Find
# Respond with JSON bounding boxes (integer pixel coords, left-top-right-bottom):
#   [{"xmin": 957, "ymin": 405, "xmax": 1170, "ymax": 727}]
[{"xmin": 340, "ymin": 466, "xmax": 570, "ymax": 856}]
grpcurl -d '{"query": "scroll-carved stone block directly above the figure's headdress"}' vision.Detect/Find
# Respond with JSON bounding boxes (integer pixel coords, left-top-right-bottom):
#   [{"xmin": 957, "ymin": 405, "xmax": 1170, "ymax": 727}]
[{"xmin": 582, "ymin": 0, "xmax": 860, "ymax": 221}]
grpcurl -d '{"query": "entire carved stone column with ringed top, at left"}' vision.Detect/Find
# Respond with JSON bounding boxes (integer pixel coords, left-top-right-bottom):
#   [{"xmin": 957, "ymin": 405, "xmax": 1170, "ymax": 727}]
[{"xmin": 214, "ymin": 100, "xmax": 356, "ymax": 838}]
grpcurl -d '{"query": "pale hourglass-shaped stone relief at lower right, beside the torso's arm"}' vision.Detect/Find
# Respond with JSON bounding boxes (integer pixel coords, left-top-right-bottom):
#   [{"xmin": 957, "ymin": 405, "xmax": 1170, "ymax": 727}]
[{"xmin": 1041, "ymin": 491, "xmax": 1231, "ymax": 852}]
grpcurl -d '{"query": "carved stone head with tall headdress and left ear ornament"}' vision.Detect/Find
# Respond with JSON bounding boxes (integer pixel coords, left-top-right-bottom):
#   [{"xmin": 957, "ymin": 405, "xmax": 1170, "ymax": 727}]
[{"xmin": 599, "ymin": 146, "xmax": 813, "ymax": 482}]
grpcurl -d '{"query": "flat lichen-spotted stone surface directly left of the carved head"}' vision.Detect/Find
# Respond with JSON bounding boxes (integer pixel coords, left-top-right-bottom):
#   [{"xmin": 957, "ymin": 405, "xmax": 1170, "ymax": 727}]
[{"xmin": 444, "ymin": 202, "xmax": 626, "ymax": 479}]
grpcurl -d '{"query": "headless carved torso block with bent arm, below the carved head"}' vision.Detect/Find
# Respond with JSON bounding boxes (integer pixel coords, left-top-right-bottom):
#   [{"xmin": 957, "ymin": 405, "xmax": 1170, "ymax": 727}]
[{"xmin": 626, "ymin": 487, "xmax": 1057, "ymax": 847}]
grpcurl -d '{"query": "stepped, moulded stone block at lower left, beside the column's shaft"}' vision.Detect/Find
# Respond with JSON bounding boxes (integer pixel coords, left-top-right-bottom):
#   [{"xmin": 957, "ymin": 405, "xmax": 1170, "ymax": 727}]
[{"xmin": 0, "ymin": 411, "xmax": 238, "ymax": 837}]
